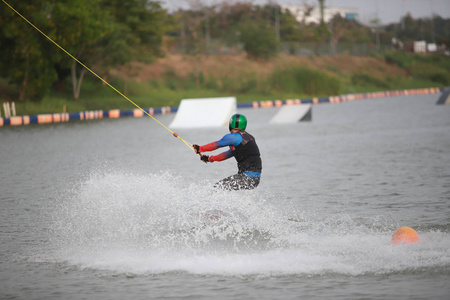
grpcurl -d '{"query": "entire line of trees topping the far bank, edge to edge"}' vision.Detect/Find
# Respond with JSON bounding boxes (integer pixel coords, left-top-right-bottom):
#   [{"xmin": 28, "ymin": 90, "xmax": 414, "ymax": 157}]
[{"xmin": 0, "ymin": 0, "xmax": 450, "ymax": 101}]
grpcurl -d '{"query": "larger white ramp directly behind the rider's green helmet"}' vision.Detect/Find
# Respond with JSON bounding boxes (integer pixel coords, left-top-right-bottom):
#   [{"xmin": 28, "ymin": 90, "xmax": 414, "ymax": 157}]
[{"xmin": 169, "ymin": 97, "xmax": 237, "ymax": 128}]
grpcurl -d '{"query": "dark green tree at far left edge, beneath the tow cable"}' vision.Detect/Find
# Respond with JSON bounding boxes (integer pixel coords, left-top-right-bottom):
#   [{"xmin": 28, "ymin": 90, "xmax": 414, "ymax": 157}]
[{"xmin": 0, "ymin": 0, "xmax": 56, "ymax": 101}]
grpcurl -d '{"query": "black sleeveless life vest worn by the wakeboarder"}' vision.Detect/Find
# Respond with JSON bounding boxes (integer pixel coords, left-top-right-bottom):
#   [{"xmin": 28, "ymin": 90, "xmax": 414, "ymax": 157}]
[{"xmin": 231, "ymin": 131, "xmax": 262, "ymax": 174}]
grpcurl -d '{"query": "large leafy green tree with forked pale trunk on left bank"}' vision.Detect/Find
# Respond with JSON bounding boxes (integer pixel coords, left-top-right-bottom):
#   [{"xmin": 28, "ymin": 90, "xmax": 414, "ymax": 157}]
[{"xmin": 49, "ymin": 0, "xmax": 168, "ymax": 99}]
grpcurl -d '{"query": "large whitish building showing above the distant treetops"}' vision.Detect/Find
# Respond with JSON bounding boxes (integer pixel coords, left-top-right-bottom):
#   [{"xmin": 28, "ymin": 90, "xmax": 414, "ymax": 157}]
[{"xmin": 281, "ymin": 5, "xmax": 358, "ymax": 24}]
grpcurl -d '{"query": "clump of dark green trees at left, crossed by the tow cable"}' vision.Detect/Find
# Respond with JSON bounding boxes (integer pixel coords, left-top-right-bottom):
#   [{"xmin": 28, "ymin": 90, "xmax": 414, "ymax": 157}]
[{"xmin": 0, "ymin": 0, "xmax": 170, "ymax": 101}]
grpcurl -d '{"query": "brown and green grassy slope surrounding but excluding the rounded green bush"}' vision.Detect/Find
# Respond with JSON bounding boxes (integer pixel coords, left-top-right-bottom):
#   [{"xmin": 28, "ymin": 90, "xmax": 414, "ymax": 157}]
[{"xmin": 12, "ymin": 55, "xmax": 448, "ymax": 115}]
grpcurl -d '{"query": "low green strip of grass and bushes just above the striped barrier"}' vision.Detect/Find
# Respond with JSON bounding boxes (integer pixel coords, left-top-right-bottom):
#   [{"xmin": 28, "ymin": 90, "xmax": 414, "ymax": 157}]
[{"xmin": 9, "ymin": 55, "xmax": 446, "ymax": 114}]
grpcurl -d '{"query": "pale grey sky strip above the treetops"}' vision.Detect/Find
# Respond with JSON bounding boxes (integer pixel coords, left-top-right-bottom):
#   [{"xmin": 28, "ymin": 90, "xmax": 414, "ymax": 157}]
[{"xmin": 161, "ymin": 0, "xmax": 450, "ymax": 24}]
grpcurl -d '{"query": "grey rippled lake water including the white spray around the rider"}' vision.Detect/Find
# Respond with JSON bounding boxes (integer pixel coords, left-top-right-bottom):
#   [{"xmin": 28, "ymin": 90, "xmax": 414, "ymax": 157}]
[{"xmin": 0, "ymin": 95, "xmax": 450, "ymax": 299}]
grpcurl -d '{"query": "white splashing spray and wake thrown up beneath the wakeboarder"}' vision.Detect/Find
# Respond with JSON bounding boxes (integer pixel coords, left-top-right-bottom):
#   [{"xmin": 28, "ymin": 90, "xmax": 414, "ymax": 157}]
[{"xmin": 50, "ymin": 173, "xmax": 450, "ymax": 275}]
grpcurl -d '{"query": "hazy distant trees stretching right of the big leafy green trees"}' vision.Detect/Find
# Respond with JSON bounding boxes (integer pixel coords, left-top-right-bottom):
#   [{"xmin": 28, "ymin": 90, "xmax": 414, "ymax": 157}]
[{"xmin": 167, "ymin": 0, "xmax": 450, "ymax": 58}]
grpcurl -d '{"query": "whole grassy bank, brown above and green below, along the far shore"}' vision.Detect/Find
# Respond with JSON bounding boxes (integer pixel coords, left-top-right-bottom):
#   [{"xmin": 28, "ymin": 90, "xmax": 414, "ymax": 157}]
[{"xmin": 4, "ymin": 52, "xmax": 450, "ymax": 115}]
